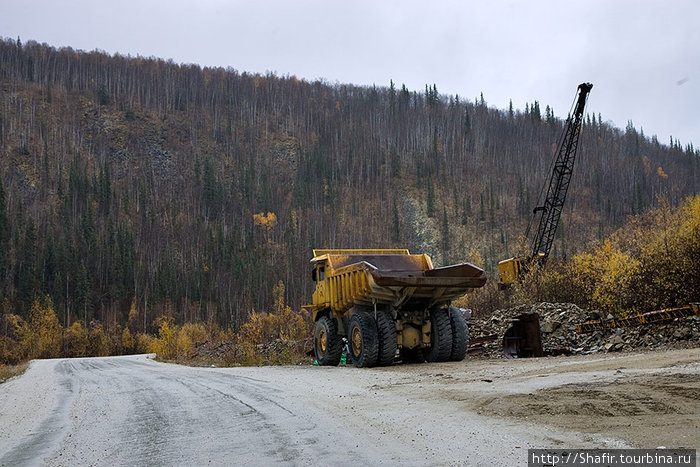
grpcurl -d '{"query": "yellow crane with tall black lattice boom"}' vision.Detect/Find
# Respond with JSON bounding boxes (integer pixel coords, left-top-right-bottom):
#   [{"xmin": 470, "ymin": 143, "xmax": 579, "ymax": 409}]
[{"xmin": 498, "ymin": 83, "xmax": 593, "ymax": 287}]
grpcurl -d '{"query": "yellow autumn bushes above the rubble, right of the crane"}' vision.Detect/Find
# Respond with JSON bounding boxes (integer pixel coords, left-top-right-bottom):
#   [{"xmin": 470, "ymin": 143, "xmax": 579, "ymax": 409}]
[{"xmin": 538, "ymin": 195, "xmax": 700, "ymax": 316}]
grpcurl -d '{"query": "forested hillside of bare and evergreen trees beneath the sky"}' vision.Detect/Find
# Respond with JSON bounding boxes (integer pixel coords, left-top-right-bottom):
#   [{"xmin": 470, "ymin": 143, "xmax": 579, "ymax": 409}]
[{"xmin": 0, "ymin": 40, "xmax": 700, "ymax": 331}]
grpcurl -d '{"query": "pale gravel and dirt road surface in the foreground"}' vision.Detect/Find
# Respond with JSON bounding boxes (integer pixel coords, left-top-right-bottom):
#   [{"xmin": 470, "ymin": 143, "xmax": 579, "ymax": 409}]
[{"xmin": 0, "ymin": 349, "xmax": 700, "ymax": 466}]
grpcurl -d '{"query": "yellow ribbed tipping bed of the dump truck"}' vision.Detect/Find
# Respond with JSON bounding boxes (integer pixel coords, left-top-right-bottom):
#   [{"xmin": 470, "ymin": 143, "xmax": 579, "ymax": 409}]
[{"xmin": 311, "ymin": 250, "xmax": 486, "ymax": 313}]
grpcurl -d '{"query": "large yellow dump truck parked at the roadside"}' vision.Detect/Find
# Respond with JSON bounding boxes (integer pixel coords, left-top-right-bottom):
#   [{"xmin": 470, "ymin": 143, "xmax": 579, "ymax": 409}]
[{"xmin": 305, "ymin": 249, "xmax": 486, "ymax": 367}]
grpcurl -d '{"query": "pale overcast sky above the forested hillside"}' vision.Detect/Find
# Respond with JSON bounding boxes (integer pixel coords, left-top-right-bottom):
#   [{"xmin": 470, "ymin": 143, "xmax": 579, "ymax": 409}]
[{"xmin": 0, "ymin": 0, "xmax": 700, "ymax": 148}]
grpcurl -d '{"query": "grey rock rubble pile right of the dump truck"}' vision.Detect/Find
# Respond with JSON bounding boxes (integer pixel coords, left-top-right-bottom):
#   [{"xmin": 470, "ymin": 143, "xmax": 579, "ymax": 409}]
[{"xmin": 469, "ymin": 303, "xmax": 700, "ymax": 357}]
